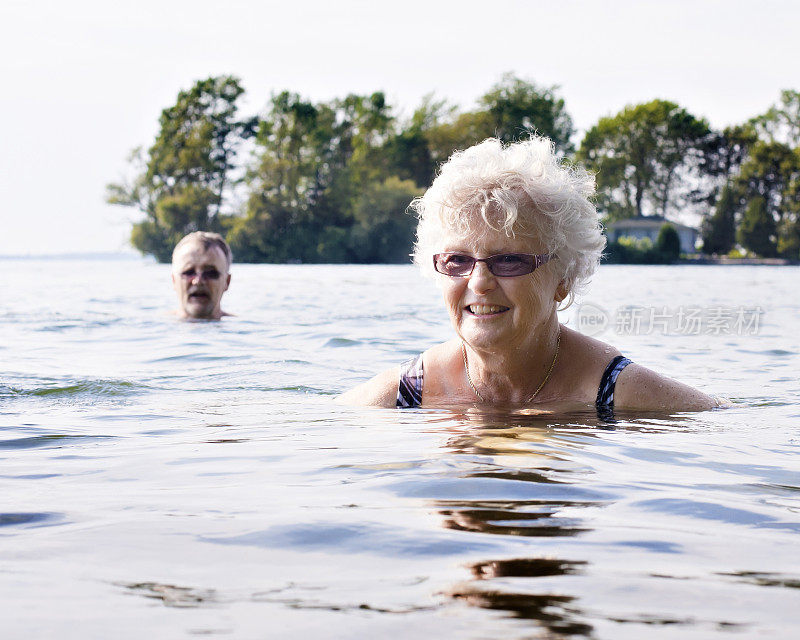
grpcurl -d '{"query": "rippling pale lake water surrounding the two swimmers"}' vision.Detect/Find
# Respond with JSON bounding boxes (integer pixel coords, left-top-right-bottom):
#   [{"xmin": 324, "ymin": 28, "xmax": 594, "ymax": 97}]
[{"xmin": 0, "ymin": 260, "xmax": 800, "ymax": 640}]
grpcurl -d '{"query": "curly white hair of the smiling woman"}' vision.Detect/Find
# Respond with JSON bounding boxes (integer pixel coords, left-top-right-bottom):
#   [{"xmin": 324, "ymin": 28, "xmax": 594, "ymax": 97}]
[{"xmin": 411, "ymin": 136, "xmax": 606, "ymax": 308}]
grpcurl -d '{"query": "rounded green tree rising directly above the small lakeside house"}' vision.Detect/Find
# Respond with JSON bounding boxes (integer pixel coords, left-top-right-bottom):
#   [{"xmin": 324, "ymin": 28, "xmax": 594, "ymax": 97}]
[{"xmin": 578, "ymin": 100, "xmax": 712, "ymax": 220}]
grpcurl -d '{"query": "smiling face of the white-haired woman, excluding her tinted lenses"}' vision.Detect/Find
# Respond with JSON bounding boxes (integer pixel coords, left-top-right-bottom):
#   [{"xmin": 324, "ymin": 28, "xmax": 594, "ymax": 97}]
[{"xmin": 437, "ymin": 229, "xmax": 563, "ymax": 350}]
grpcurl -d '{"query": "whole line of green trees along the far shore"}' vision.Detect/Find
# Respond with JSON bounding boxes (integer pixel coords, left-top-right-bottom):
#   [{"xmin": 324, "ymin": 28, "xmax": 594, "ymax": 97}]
[{"xmin": 107, "ymin": 74, "xmax": 800, "ymax": 263}]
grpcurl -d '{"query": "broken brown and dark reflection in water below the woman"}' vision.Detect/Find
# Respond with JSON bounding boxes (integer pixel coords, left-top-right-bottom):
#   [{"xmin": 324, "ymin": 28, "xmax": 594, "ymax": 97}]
[{"xmin": 424, "ymin": 412, "xmax": 609, "ymax": 638}]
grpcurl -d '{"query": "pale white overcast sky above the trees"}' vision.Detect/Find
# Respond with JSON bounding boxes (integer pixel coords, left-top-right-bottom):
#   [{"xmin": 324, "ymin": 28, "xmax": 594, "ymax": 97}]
[{"xmin": 0, "ymin": 0, "xmax": 800, "ymax": 255}]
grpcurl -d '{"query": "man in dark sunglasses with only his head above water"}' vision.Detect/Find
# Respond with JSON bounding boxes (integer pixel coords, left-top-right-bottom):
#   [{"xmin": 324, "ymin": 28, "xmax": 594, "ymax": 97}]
[{"xmin": 172, "ymin": 231, "xmax": 233, "ymax": 320}]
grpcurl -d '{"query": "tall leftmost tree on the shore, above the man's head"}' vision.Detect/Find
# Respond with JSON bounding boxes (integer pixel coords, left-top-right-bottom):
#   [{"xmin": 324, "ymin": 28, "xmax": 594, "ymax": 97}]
[{"xmin": 107, "ymin": 76, "xmax": 253, "ymax": 262}]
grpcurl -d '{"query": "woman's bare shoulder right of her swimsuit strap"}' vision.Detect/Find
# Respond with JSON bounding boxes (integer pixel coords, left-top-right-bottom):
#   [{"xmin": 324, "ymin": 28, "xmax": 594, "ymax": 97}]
[{"xmin": 614, "ymin": 363, "xmax": 725, "ymax": 411}]
